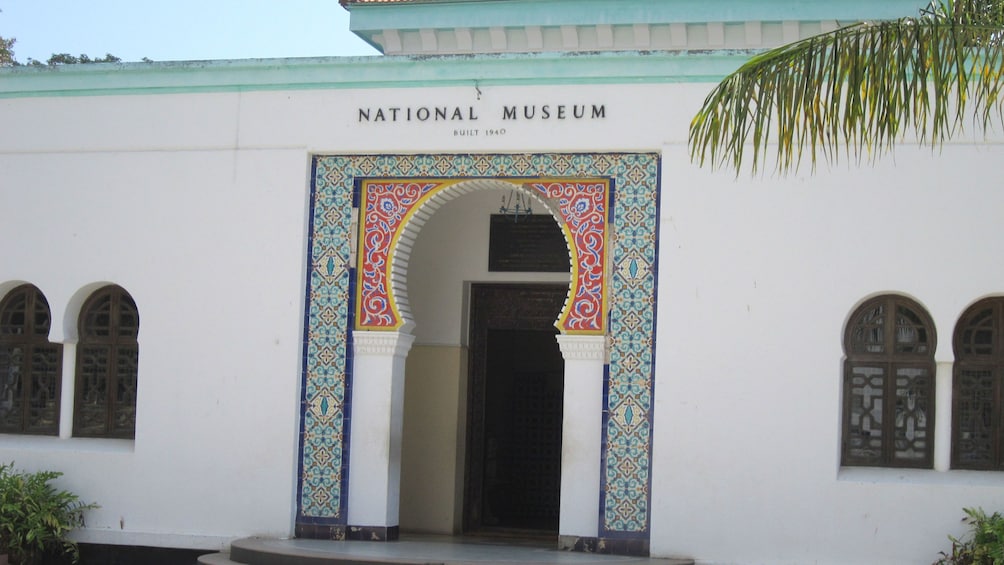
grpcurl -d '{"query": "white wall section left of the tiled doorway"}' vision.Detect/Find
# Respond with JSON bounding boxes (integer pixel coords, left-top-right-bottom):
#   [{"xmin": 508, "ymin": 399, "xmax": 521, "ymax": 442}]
[{"xmin": 0, "ymin": 91, "xmax": 308, "ymax": 547}]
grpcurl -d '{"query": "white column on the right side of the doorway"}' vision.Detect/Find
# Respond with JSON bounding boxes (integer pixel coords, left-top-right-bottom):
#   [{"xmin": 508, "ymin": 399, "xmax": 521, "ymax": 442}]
[{"xmin": 557, "ymin": 335, "xmax": 606, "ymax": 539}]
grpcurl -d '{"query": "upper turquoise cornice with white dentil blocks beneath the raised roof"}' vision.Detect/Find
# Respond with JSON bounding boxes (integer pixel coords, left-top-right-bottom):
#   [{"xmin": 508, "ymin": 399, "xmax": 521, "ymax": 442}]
[{"xmin": 349, "ymin": 0, "xmax": 928, "ymax": 55}]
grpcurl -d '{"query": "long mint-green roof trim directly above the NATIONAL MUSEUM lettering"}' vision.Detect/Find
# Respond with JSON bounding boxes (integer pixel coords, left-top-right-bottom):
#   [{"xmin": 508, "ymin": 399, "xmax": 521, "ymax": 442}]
[{"xmin": 0, "ymin": 50, "xmax": 753, "ymax": 98}]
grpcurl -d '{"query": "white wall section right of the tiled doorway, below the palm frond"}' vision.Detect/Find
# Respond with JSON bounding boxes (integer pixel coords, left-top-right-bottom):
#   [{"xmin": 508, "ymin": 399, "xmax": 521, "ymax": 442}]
[{"xmin": 653, "ymin": 145, "xmax": 1004, "ymax": 563}]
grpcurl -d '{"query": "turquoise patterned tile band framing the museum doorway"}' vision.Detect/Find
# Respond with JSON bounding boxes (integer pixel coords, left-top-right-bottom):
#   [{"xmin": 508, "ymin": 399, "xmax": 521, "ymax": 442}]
[{"xmin": 297, "ymin": 154, "xmax": 659, "ymax": 539}]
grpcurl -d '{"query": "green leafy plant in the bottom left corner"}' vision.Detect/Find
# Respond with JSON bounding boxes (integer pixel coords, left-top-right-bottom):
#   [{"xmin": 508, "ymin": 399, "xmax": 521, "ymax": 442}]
[{"xmin": 0, "ymin": 464, "xmax": 97, "ymax": 565}]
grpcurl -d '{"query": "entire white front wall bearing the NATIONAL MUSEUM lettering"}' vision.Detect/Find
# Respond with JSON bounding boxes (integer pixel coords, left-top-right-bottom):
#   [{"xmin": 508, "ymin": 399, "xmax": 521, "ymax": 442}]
[{"xmin": 0, "ymin": 72, "xmax": 1004, "ymax": 564}]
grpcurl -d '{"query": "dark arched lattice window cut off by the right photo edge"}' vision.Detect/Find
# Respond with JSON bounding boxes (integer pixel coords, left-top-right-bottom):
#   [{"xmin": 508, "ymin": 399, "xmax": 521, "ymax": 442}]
[{"xmin": 952, "ymin": 298, "xmax": 1004, "ymax": 470}]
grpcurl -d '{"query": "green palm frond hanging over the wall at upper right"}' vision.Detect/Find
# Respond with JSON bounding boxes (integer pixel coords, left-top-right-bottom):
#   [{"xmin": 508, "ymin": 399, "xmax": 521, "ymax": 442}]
[{"xmin": 689, "ymin": 0, "xmax": 1004, "ymax": 174}]
